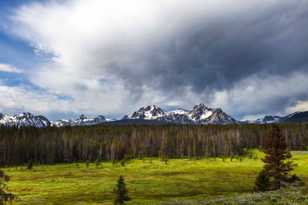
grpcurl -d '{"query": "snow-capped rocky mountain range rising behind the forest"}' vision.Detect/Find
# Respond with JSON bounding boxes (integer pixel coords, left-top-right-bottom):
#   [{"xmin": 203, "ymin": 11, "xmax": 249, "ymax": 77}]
[{"xmin": 0, "ymin": 104, "xmax": 308, "ymax": 128}]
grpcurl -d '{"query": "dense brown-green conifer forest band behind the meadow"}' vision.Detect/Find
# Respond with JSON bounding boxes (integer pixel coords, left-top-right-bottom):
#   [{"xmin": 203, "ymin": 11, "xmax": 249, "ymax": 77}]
[{"xmin": 0, "ymin": 124, "xmax": 308, "ymax": 166}]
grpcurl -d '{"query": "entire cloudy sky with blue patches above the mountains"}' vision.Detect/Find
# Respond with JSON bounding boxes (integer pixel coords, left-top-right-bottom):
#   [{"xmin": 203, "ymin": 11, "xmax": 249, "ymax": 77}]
[{"xmin": 0, "ymin": 0, "xmax": 308, "ymax": 119}]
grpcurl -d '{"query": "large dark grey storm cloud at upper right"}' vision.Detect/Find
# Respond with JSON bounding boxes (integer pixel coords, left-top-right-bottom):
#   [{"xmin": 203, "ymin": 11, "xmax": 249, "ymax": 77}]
[{"xmin": 111, "ymin": 1, "xmax": 308, "ymax": 92}]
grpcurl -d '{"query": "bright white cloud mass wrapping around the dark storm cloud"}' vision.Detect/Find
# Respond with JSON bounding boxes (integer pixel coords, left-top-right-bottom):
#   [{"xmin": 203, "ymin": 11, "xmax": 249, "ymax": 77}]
[{"xmin": 0, "ymin": 0, "xmax": 308, "ymax": 118}]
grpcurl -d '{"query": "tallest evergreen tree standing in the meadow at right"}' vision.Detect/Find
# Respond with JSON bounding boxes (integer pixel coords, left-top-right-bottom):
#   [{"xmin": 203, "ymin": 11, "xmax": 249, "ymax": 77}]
[{"xmin": 255, "ymin": 125, "xmax": 294, "ymax": 191}]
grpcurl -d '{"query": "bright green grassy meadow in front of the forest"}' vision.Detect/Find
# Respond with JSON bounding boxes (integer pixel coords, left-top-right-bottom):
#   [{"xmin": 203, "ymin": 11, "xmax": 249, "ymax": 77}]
[{"xmin": 4, "ymin": 152, "xmax": 308, "ymax": 205}]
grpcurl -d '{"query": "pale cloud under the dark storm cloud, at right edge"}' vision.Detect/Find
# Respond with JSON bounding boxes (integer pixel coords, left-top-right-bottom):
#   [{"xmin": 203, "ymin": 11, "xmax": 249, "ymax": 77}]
[{"xmin": 212, "ymin": 72, "xmax": 308, "ymax": 119}]
